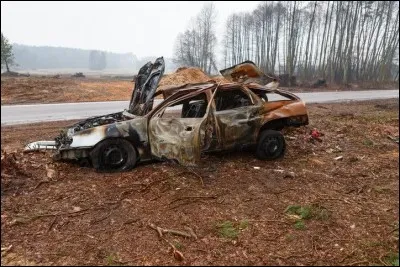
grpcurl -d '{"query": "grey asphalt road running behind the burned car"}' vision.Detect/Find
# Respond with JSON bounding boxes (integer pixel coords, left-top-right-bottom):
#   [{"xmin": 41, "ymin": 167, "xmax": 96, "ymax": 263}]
[{"xmin": 1, "ymin": 90, "xmax": 399, "ymax": 125}]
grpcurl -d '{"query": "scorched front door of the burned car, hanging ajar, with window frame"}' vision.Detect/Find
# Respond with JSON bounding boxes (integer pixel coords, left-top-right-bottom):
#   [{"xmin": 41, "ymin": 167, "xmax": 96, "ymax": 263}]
[{"xmin": 148, "ymin": 85, "xmax": 217, "ymax": 166}]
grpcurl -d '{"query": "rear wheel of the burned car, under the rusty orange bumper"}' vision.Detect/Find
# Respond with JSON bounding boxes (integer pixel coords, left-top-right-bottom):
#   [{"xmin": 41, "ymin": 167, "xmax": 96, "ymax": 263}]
[{"xmin": 256, "ymin": 130, "xmax": 286, "ymax": 160}]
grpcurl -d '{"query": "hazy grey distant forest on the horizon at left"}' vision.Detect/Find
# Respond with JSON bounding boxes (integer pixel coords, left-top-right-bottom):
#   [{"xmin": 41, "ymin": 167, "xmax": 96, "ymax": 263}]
[{"xmin": 13, "ymin": 43, "xmax": 175, "ymax": 72}]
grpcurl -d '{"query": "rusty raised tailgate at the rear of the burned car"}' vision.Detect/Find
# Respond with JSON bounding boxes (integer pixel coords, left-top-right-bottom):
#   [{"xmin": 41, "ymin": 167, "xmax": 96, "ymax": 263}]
[{"xmin": 219, "ymin": 60, "xmax": 264, "ymax": 82}]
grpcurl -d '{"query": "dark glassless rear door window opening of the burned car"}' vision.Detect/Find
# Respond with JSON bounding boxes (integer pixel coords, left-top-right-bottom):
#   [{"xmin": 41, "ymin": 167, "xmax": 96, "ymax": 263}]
[{"xmin": 215, "ymin": 89, "xmax": 253, "ymax": 111}]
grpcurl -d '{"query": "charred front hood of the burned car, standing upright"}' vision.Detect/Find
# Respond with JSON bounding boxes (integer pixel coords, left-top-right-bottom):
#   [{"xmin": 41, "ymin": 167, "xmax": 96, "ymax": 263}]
[{"xmin": 129, "ymin": 57, "xmax": 165, "ymax": 116}]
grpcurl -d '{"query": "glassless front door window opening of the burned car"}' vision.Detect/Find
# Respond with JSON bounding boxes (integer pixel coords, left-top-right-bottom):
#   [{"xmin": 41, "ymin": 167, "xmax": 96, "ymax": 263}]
[{"xmin": 159, "ymin": 93, "xmax": 207, "ymax": 118}]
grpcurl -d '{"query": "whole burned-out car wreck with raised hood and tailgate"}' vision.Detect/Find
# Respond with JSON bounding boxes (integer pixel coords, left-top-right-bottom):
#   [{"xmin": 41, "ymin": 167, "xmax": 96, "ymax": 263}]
[{"xmin": 25, "ymin": 57, "xmax": 308, "ymax": 171}]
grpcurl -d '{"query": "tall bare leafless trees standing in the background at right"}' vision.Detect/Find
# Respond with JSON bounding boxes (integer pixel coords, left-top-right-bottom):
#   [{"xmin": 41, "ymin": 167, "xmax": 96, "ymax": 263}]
[{"xmin": 175, "ymin": 1, "xmax": 399, "ymax": 83}]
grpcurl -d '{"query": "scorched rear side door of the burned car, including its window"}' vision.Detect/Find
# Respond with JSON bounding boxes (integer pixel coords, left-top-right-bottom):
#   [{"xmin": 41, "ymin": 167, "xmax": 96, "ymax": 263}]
[{"xmin": 214, "ymin": 86, "xmax": 262, "ymax": 149}]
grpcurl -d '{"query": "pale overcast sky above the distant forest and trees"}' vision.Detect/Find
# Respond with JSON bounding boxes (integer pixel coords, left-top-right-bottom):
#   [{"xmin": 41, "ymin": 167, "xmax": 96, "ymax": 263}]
[{"xmin": 1, "ymin": 1, "xmax": 259, "ymax": 58}]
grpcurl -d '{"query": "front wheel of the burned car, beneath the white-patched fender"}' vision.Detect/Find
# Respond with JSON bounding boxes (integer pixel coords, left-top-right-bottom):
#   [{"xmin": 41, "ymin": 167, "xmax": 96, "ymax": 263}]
[{"xmin": 90, "ymin": 139, "xmax": 137, "ymax": 172}]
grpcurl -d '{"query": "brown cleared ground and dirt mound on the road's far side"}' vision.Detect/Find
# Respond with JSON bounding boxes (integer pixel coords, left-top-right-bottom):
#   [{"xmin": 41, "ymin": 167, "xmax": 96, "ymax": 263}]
[{"xmin": 1, "ymin": 71, "xmax": 398, "ymax": 105}]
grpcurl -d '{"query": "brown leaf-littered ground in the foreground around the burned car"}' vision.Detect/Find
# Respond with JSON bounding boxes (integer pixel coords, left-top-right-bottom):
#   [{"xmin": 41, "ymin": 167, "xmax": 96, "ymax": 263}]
[{"xmin": 1, "ymin": 99, "xmax": 399, "ymax": 266}]
